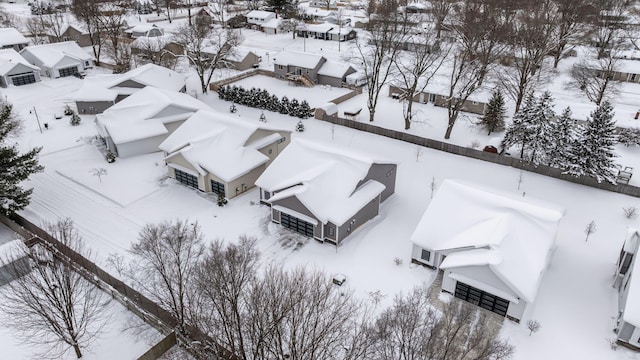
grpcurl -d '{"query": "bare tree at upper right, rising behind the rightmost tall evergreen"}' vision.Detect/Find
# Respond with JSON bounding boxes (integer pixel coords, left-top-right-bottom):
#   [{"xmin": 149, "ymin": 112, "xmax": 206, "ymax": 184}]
[{"xmin": 568, "ymin": 46, "xmax": 620, "ymax": 105}]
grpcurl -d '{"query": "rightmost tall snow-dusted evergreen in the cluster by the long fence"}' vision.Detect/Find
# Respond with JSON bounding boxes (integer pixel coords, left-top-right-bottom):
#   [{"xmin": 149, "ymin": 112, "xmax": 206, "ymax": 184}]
[{"xmin": 566, "ymin": 100, "xmax": 617, "ymax": 184}]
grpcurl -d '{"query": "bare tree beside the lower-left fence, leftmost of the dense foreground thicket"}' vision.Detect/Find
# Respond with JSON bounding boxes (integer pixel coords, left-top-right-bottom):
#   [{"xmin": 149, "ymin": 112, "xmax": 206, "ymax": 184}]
[{"xmin": 128, "ymin": 220, "xmax": 205, "ymax": 332}]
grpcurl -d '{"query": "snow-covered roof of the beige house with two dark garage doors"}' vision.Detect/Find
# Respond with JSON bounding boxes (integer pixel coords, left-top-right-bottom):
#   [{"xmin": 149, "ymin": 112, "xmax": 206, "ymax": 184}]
[{"xmin": 160, "ymin": 110, "xmax": 289, "ymax": 182}]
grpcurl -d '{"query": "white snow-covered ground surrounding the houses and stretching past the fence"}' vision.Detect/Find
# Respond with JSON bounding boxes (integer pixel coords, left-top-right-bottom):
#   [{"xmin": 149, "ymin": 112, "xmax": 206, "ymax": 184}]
[{"xmin": 0, "ymin": 1, "xmax": 640, "ymax": 360}]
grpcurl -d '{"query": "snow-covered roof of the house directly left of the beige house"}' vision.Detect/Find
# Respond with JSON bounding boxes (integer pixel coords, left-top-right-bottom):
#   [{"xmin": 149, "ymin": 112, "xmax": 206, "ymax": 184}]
[{"xmin": 96, "ymin": 86, "xmax": 210, "ymax": 144}]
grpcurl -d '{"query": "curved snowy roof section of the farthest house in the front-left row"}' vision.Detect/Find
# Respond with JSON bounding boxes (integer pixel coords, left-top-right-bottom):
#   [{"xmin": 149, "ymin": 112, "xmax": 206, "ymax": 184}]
[{"xmin": 109, "ymin": 64, "xmax": 186, "ymax": 91}]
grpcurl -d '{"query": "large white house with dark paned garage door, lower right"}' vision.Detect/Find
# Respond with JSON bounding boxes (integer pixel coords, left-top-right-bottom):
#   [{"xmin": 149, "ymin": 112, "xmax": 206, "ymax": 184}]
[{"xmin": 411, "ymin": 180, "xmax": 564, "ymax": 322}]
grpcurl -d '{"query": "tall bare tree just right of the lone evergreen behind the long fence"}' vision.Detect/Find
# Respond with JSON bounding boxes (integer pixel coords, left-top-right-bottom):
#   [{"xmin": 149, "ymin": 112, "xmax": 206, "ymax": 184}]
[{"xmin": 499, "ymin": 0, "xmax": 555, "ymax": 112}]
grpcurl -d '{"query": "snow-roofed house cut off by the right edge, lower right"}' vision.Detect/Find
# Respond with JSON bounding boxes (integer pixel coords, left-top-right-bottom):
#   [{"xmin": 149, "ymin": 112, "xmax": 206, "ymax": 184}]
[{"xmin": 614, "ymin": 229, "xmax": 640, "ymax": 350}]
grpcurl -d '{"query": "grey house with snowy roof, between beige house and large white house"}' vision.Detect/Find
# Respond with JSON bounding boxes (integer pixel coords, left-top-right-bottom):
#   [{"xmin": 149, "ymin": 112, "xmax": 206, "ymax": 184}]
[{"xmin": 255, "ymin": 139, "xmax": 397, "ymax": 245}]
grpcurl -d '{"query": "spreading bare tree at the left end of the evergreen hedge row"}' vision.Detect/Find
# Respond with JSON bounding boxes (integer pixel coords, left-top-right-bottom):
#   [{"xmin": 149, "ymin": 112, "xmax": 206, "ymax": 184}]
[{"xmin": 174, "ymin": 24, "xmax": 241, "ymax": 93}]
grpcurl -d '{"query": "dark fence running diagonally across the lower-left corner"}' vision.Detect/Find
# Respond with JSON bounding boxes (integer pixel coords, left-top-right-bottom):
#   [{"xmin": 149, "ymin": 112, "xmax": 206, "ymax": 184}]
[{"xmin": 0, "ymin": 214, "xmax": 237, "ymax": 360}]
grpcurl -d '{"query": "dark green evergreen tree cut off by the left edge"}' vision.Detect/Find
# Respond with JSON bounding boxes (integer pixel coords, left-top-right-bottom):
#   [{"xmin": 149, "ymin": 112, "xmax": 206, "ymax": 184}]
[{"xmin": 0, "ymin": 103, "xmax": 43, "ymax": 215}]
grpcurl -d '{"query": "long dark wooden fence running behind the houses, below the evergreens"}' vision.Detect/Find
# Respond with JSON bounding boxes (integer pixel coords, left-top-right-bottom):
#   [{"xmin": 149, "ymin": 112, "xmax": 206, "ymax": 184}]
[{"xmin": 315, "ymin": 109, "xmax": 640, "ymax": 197}]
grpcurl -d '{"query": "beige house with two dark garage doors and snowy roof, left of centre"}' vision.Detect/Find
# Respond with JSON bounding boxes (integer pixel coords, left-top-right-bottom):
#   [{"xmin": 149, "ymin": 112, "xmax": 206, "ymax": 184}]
[{"xmin": 160, "ymin": 110, "xmax": 291, "ymax": 199}]
